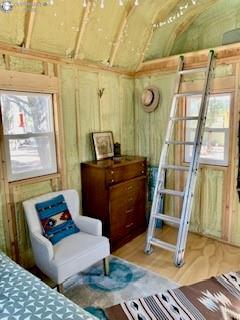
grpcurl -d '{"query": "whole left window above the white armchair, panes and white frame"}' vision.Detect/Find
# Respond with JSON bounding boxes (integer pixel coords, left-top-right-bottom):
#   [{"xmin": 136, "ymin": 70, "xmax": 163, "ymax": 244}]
[{"xmin": 0, "ymin": 91, "xmax": 57, "ymax": 181}]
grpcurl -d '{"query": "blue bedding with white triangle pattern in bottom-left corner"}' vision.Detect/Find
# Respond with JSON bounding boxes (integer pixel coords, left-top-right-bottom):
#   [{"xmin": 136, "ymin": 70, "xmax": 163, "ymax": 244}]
[{"xmin": 0, "ymin": 252, "xmax": 96, "ymax": 320}]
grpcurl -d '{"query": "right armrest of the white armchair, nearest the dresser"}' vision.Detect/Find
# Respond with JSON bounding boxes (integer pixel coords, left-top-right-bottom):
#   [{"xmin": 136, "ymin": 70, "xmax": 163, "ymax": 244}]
[{"xmin": 74, "ymin": 215, "xmax": 102, "ymax": 236}]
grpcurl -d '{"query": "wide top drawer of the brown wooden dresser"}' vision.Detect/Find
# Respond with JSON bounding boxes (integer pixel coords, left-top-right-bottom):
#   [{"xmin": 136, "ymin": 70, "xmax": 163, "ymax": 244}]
[{"xmin": 106, "ymin": 161, "xmax": 147, "ymax": 186}]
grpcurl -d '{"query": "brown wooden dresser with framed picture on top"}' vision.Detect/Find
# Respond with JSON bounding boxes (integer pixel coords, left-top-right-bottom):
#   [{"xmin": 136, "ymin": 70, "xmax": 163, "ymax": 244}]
[{"xmin": 81, "ymin": 156, "xmax": 147, "ymax": 251}]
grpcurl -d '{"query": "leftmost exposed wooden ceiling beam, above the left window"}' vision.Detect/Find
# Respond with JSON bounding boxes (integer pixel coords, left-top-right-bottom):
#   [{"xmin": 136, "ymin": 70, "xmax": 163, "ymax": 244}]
[{"xmin": 23, "ymin": 0, "xmax": 37, "ymax": 49}]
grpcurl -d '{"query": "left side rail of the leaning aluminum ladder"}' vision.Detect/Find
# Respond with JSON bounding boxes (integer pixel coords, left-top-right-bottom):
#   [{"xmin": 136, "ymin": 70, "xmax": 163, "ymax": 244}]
[{"xmin": 145, "ymin": 56, "xmax": 184, "ymax": 252}]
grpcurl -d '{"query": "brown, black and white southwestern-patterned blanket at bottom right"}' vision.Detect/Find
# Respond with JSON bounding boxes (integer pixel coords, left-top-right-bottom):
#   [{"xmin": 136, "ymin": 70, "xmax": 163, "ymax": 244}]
[{"xmin": 105, "ymin": 272, "xmax": 240, "ymax": 320}]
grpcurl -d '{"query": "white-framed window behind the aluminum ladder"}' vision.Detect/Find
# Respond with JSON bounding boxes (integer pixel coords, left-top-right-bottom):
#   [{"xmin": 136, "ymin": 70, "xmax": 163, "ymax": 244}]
[{"xmin": 185, "ymin": 94, "xmax": 231, "ymax": 166}]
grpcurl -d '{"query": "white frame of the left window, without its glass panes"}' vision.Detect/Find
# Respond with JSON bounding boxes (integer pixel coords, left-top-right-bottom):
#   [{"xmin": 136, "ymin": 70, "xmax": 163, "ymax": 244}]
[{"xmin": 0, "ymin": 90, "xmax": 59, "ymax": 183}]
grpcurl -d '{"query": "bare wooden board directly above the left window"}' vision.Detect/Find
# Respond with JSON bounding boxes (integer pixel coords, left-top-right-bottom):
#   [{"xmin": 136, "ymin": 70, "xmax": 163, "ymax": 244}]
[{"xmin": 0, "ymin": 70, "xmax": 59, "ymax": 93}]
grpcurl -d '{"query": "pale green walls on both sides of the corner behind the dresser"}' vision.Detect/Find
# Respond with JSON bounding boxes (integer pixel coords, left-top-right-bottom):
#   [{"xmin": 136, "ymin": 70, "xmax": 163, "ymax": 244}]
[{"xmin": 0, "ymin": 58, "xmax": 240, "ymax": 266}]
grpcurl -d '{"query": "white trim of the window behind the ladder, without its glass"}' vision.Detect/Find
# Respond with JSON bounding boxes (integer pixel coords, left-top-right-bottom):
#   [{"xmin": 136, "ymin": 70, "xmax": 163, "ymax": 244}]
[{"xmin": 184, "ymin": 93, "xmax": 232, "ymax": 167}]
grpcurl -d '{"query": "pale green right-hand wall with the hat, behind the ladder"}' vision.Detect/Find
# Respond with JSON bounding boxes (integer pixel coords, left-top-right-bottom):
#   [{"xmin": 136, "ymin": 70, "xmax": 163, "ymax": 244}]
[{"xmin": 135, "ymin": 64, "xmax": 240, "ymax": 245}]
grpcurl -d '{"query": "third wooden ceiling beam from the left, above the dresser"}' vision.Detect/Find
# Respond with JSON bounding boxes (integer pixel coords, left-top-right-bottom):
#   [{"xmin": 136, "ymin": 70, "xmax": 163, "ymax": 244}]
[{"xmin": 109, "ymin": 5, "xmax": 136, "ymax": 67}]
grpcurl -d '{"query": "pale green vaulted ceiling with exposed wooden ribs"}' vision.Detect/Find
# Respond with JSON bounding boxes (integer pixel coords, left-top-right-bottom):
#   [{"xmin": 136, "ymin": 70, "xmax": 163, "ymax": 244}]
[{"xmin": 0, "ymin": 0, "xmax": 240, "ymax": 70}]
